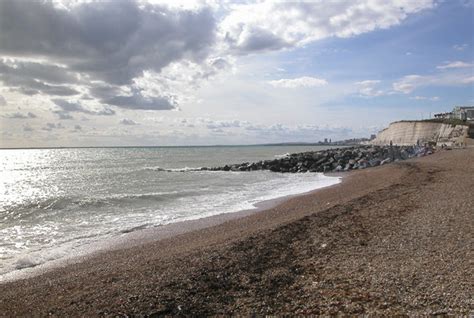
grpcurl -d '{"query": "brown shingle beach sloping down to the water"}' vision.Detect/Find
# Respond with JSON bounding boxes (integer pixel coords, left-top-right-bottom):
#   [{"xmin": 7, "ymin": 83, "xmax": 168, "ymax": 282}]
[{"xmin": 0, "ymin": 148, "xmax": 474, "ymax": 317}]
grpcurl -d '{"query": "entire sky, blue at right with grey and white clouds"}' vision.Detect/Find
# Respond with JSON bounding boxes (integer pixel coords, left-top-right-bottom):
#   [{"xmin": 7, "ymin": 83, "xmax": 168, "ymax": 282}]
[{"xmin": 0, "ymin": 0, "xmax": 474, "ymax": 148}]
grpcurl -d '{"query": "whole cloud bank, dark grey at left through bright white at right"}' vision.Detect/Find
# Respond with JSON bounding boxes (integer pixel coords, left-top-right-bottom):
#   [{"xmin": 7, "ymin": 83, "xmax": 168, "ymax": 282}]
[{"xmin": 0, "ymin": 0, "xmax": 434, "ymax": 114}]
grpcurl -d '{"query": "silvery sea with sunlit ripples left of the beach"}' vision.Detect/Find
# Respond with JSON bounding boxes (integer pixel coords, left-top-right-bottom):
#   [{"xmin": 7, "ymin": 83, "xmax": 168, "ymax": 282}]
[{"xmin": 0, "ymin": 146, "xmax": 340, "ymax": 281}]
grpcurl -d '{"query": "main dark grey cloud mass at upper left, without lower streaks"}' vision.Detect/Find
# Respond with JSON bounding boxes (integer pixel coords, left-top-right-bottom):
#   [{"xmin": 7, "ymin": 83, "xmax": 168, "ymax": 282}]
[{"xmin": 0, "ymin": 0, "xmax": 215, "ymax": 84}]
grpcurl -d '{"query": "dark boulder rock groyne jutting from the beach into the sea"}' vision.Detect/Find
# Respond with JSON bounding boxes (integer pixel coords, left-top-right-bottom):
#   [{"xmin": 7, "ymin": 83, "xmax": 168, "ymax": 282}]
[{"xmin": 201, "ymin": 146, "xmax": 433, "ymax": 173}]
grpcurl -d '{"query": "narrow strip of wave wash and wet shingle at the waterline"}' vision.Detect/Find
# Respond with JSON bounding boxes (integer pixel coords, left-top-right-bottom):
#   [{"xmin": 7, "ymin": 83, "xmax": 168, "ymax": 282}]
[{"xmin": 0, "ymin": 172, "xmax": 340, "ymax": 286}]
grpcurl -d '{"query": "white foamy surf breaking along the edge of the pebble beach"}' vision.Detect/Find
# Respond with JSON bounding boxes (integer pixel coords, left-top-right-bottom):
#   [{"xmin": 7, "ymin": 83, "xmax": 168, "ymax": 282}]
[{"xmin": 0, "ymin": 171, "xmax": 341, "ymax": 282}]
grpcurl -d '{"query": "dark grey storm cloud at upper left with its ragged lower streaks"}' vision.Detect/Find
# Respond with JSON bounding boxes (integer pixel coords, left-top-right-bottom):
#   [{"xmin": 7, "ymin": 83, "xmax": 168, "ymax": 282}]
[{"xmin": 0, "ymin": 0, "xmax": 216, "ymax": 109}]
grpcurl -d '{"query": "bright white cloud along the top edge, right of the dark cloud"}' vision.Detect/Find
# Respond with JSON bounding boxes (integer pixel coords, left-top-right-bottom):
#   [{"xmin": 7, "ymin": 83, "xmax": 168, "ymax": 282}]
[{"xmin": 219, "ymin": 0, "xmax": 434, "ymax": 54}]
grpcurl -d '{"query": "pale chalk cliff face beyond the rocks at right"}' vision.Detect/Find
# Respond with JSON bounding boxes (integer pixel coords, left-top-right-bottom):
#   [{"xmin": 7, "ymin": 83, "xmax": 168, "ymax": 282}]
[{"xmin": 371, "ymin": 121, "xmax": 468, "ymax": 146}]
